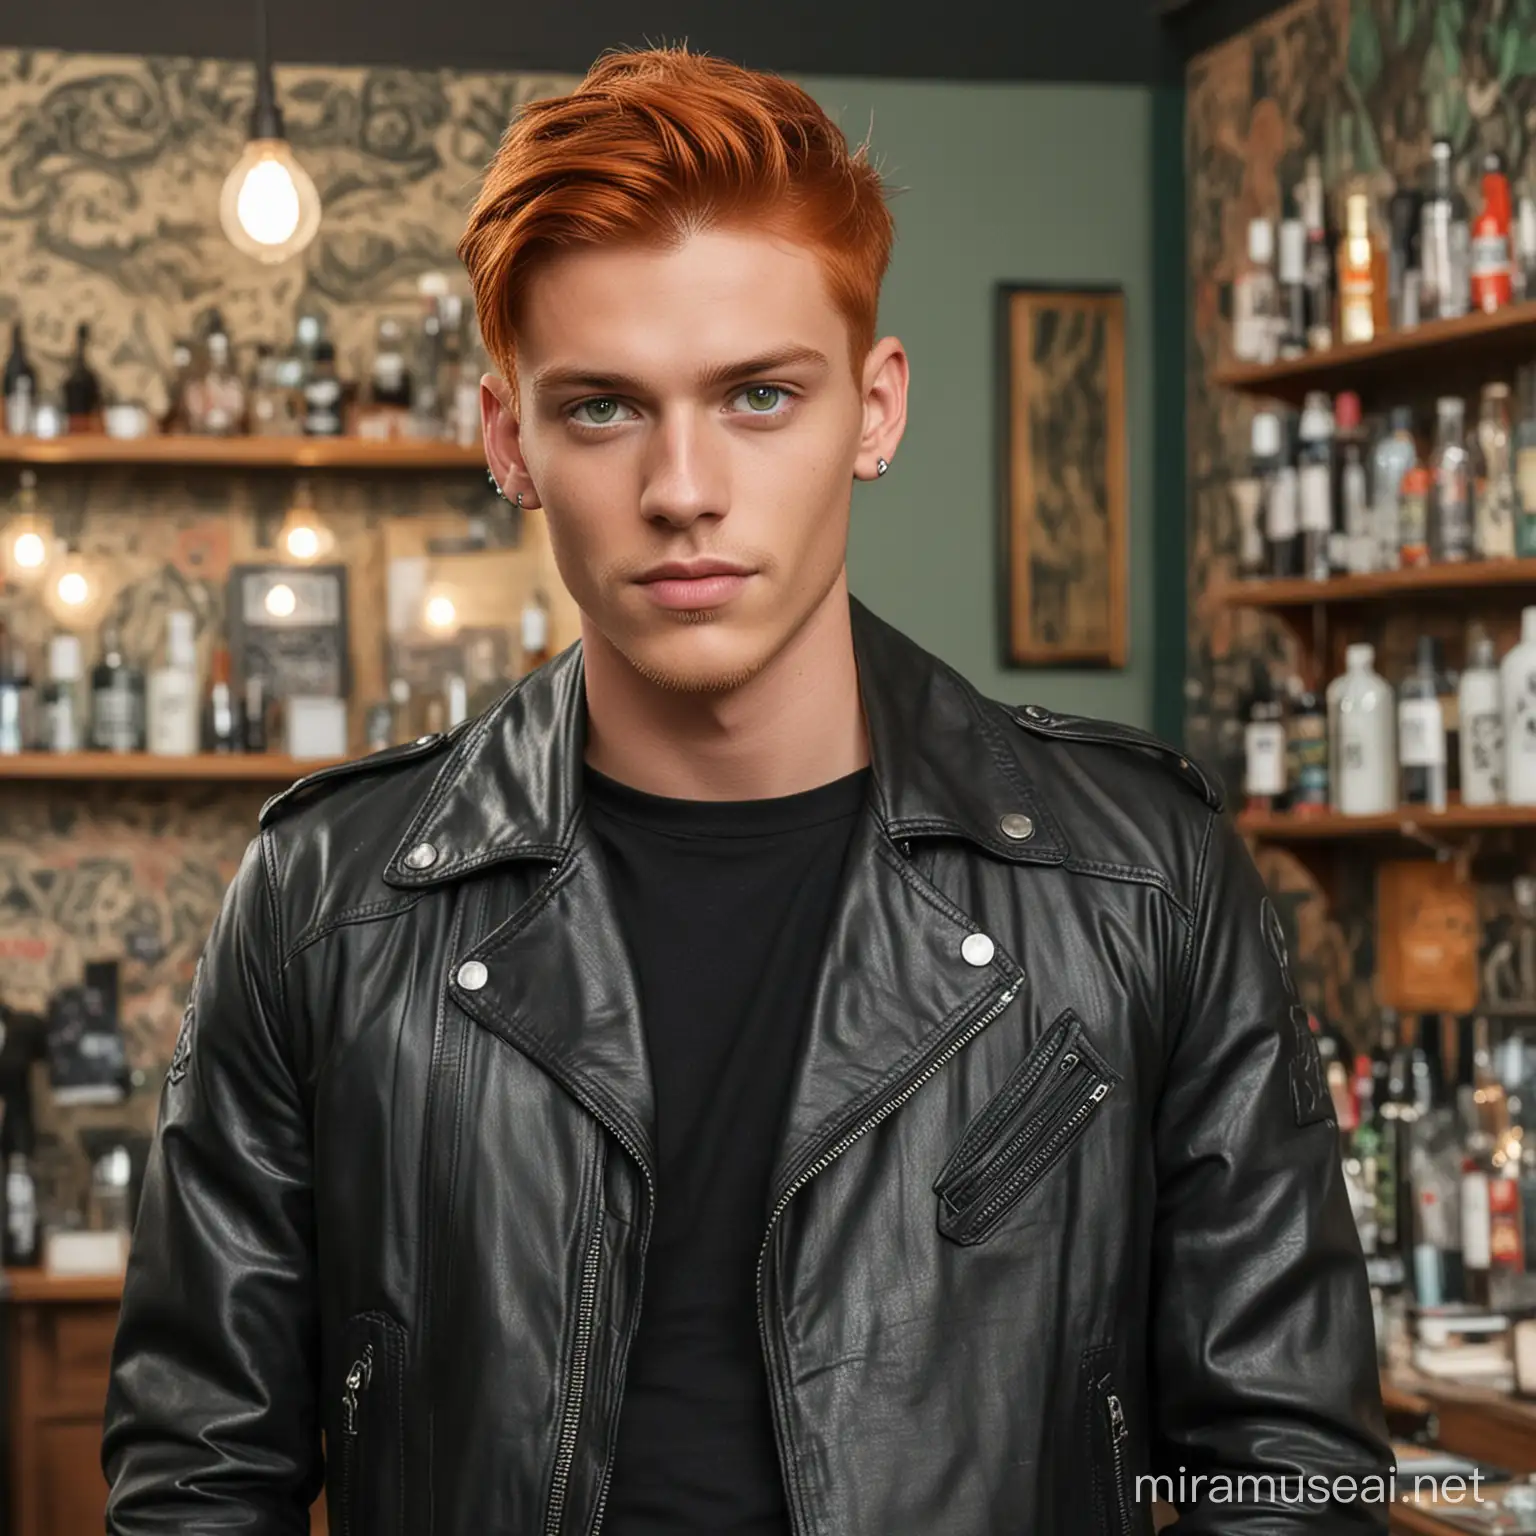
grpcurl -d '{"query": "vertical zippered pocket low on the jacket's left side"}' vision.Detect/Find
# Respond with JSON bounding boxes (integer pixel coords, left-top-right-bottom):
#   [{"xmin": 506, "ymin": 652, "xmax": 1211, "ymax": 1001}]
[{"xmin": 327, "ymin": 1312, "xmax": 406, "ymax": 1536}]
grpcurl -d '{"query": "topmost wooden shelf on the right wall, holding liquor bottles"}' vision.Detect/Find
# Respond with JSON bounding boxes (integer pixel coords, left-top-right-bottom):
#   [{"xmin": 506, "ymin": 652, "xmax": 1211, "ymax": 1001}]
[{"xmin": 1217, "ymin": 303, "xmax": 1536, "ymax": 402}]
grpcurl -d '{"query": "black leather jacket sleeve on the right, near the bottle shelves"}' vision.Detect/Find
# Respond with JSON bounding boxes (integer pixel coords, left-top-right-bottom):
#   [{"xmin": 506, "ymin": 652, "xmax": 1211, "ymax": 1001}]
[{"xmin": 1150, "ymin": 816, "xmax": 1393, "ymax": 1536}]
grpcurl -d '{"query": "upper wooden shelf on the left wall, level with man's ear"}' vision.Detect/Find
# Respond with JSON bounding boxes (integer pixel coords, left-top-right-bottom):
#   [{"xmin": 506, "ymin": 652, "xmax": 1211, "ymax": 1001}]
[{"xmin": 0, "ymin": 433, "xmax": 485, "ymax": 472}]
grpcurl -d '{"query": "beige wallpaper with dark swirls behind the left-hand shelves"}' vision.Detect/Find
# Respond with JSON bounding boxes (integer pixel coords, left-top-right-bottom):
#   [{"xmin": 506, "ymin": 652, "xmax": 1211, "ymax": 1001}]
[{"xmin": 0, "ymin": 51, "xmax": 574, "ymax": 1173}]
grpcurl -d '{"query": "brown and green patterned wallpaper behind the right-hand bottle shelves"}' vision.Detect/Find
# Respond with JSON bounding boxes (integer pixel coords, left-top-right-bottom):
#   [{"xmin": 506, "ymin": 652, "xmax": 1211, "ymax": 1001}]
[{"xmin": 1186, "ymin": 0, "xmax": 1536, "ymax": 1041}]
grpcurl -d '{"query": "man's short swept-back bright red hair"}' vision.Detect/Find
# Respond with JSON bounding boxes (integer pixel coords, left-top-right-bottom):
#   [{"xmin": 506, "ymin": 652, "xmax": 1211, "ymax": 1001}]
[{"xmin": 459, "ymin": 48, "xmax": 894, "ymax": 390}]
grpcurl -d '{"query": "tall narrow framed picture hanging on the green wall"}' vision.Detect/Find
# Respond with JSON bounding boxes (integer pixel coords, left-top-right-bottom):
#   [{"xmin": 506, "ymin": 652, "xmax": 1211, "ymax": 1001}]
[{"xmin": 998, "ymin": 284, "xmax": 1126, "ymax": 667}]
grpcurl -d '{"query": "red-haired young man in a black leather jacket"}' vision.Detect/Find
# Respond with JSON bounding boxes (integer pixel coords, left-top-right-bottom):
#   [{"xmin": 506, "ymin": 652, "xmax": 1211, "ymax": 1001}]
[{"xmin": 104, "ymin": 42, "xmax": 1389, "ymax": 1536}]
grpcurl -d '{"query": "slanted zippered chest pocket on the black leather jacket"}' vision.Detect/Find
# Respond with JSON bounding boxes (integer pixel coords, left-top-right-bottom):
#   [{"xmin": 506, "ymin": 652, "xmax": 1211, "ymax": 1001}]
[{"xmin": 934, "ymin": 1011, "xmax": 1120, "ymax": 1244}]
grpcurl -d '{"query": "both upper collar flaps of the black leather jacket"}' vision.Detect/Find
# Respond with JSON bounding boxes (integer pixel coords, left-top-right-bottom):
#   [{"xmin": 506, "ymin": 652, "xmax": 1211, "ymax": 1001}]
[{"xmin": 384, "ymin": 601, "xmax": 1066, "ymax": 889}]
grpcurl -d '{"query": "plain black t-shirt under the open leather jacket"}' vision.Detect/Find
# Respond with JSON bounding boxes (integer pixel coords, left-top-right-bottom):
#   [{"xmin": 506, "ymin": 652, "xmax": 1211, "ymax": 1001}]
[{"xmin": 587, "ymin": 768, "xmax": 869, "ymax": 1536}]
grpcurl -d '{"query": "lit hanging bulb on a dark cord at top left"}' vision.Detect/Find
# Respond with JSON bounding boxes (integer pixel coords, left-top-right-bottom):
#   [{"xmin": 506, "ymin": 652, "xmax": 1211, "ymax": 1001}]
[{"xmin": 218, "ymin": 0, "xmax": 319, "ymax": 263}]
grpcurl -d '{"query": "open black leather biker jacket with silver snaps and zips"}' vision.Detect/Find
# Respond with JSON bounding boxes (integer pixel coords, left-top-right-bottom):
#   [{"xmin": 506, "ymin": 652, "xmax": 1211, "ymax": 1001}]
[{"xmin": 103, "ymin": 605, "xmax": 1390, "ymax": 1536}]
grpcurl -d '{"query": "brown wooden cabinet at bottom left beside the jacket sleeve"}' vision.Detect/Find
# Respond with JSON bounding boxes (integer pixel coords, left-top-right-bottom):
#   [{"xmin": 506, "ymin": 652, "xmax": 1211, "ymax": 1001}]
[{"xmin": 5, "ymin": 1270, "xmax": 326, "ymax": 1536}]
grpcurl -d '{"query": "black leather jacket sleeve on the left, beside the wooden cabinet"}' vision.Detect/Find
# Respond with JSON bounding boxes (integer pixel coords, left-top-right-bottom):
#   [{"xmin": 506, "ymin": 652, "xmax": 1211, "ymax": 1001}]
[{"xmin": 101, "ymin": 837, "xmax": 323, "ymax": 1536}]
